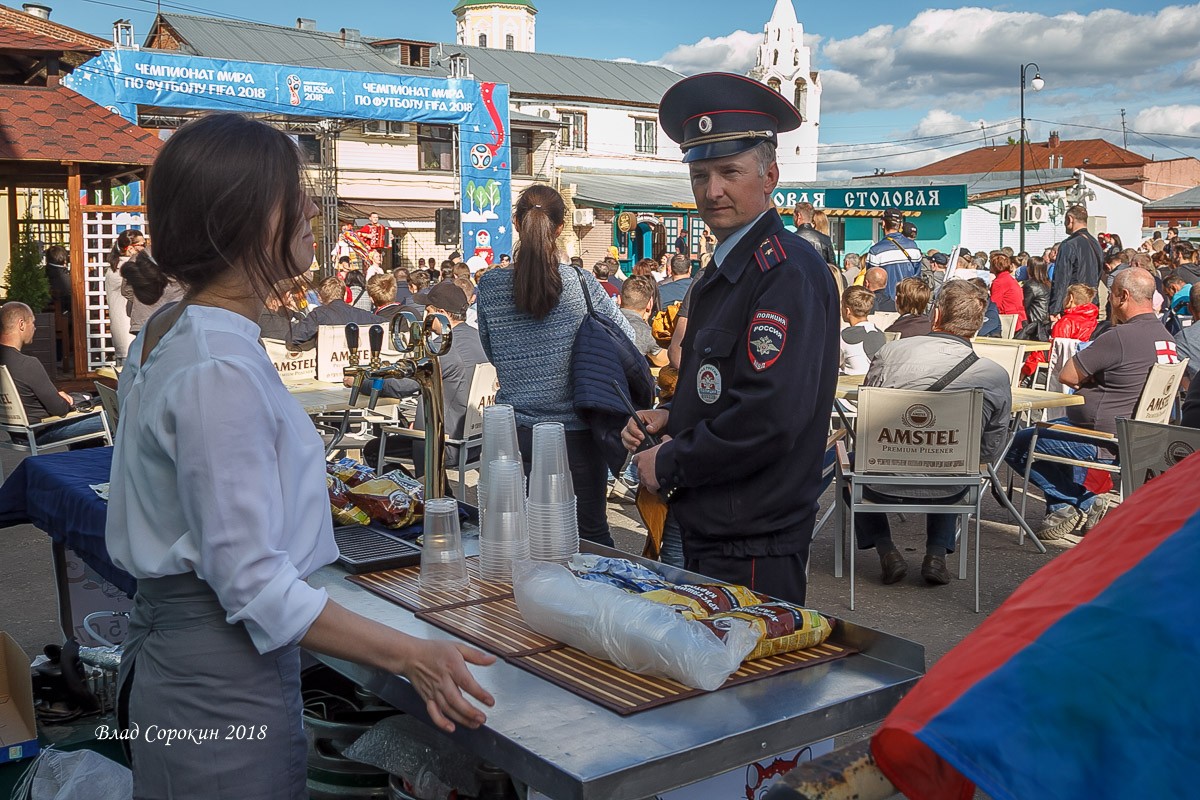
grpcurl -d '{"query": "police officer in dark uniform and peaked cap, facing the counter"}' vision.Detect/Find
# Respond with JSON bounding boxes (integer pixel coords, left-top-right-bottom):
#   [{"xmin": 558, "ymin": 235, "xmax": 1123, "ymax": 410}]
[{"xmin": 622, "ymin": 73, "xmax": 838, "ymax": 603}]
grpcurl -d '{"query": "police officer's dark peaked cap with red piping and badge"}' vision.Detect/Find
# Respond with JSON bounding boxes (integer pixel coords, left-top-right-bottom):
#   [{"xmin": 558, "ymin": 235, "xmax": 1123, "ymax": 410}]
[{"xmin": 659, "ymin": 72, "xmax": 804, "ymax": 162}]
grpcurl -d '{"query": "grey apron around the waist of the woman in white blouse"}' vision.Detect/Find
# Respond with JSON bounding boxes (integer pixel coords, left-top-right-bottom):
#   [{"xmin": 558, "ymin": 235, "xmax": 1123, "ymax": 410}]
[{"xmin": 119, "ymin": 572, "xmax": 308, "ymax": 800}]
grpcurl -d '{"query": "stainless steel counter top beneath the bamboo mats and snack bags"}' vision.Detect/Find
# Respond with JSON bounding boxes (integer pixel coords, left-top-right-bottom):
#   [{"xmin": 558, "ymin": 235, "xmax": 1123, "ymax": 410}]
[{"xmin": 310, "ymin": 548, "xmax": 925, "ymax": 800}]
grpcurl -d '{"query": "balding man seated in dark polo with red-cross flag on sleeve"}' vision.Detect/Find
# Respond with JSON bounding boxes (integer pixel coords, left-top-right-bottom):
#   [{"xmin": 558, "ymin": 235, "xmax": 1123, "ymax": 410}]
[{"xmin": 1006, "ymin": 270, "xmax": 1178, "ymax": 541}]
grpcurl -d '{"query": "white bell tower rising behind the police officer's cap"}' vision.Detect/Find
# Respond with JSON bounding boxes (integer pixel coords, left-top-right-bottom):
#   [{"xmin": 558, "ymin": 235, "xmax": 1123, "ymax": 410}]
[{"xmin": 750, "ymin": 0, "xmax": 821, "ymax": 184}]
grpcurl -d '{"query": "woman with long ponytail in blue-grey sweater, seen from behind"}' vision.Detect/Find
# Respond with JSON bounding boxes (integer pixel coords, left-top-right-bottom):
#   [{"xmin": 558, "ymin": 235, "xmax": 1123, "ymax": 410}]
[{"xmin": 478, "ymin": 185, "xmax": 634, "ymax": 547}]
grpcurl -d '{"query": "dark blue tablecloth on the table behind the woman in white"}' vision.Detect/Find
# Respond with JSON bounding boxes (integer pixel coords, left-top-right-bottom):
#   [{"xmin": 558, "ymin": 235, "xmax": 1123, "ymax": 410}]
[{"xmin": 0, "ymin": 447, "xmax": 137, "ymax": 597}]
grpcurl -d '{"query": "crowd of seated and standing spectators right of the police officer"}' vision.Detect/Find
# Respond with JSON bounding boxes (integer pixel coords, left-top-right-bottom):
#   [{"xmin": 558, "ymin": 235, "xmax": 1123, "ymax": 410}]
[{"xmin": 825, "ymin": 205, "xmax": 1200, "ymax": 554}]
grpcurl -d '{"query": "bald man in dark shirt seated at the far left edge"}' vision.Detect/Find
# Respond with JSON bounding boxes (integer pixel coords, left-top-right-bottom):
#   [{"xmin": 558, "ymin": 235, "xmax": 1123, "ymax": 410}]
[{"xmin": 0, "ymin": 302, "xmax": 103, "ymax": 445}]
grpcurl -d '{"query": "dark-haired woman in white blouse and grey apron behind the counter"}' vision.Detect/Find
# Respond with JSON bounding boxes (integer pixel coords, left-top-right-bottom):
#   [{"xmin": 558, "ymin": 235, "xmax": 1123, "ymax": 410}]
[{"xmin": 107, "ymin": 114, "xmax": 493, "ymax": 800}]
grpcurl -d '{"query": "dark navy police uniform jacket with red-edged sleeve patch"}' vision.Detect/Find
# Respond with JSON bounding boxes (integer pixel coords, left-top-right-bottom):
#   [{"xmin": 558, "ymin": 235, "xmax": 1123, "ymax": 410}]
[{"xmin": 655, "ymin": 210, "xmax": 839, "ymax": 559}]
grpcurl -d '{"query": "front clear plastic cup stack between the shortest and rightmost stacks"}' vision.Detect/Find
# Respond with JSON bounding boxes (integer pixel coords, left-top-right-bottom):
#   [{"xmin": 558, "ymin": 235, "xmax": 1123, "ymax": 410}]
[{"xmin": 479, "ymin": 461, "xmax": 529, "ymax": 583}]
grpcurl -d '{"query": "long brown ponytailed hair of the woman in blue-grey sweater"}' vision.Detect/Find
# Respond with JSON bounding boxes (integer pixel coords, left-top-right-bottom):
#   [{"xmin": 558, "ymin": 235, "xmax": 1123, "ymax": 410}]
[{"xmin": 512, "ymin": 184, "xmax": 566, "ymax": 319}]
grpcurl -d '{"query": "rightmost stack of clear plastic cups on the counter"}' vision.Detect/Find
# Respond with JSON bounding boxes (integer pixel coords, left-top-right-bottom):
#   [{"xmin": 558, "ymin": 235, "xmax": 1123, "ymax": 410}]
[{"xmin": 526, "ymin": 422, "xmax": 580, "ymax": 564}]
